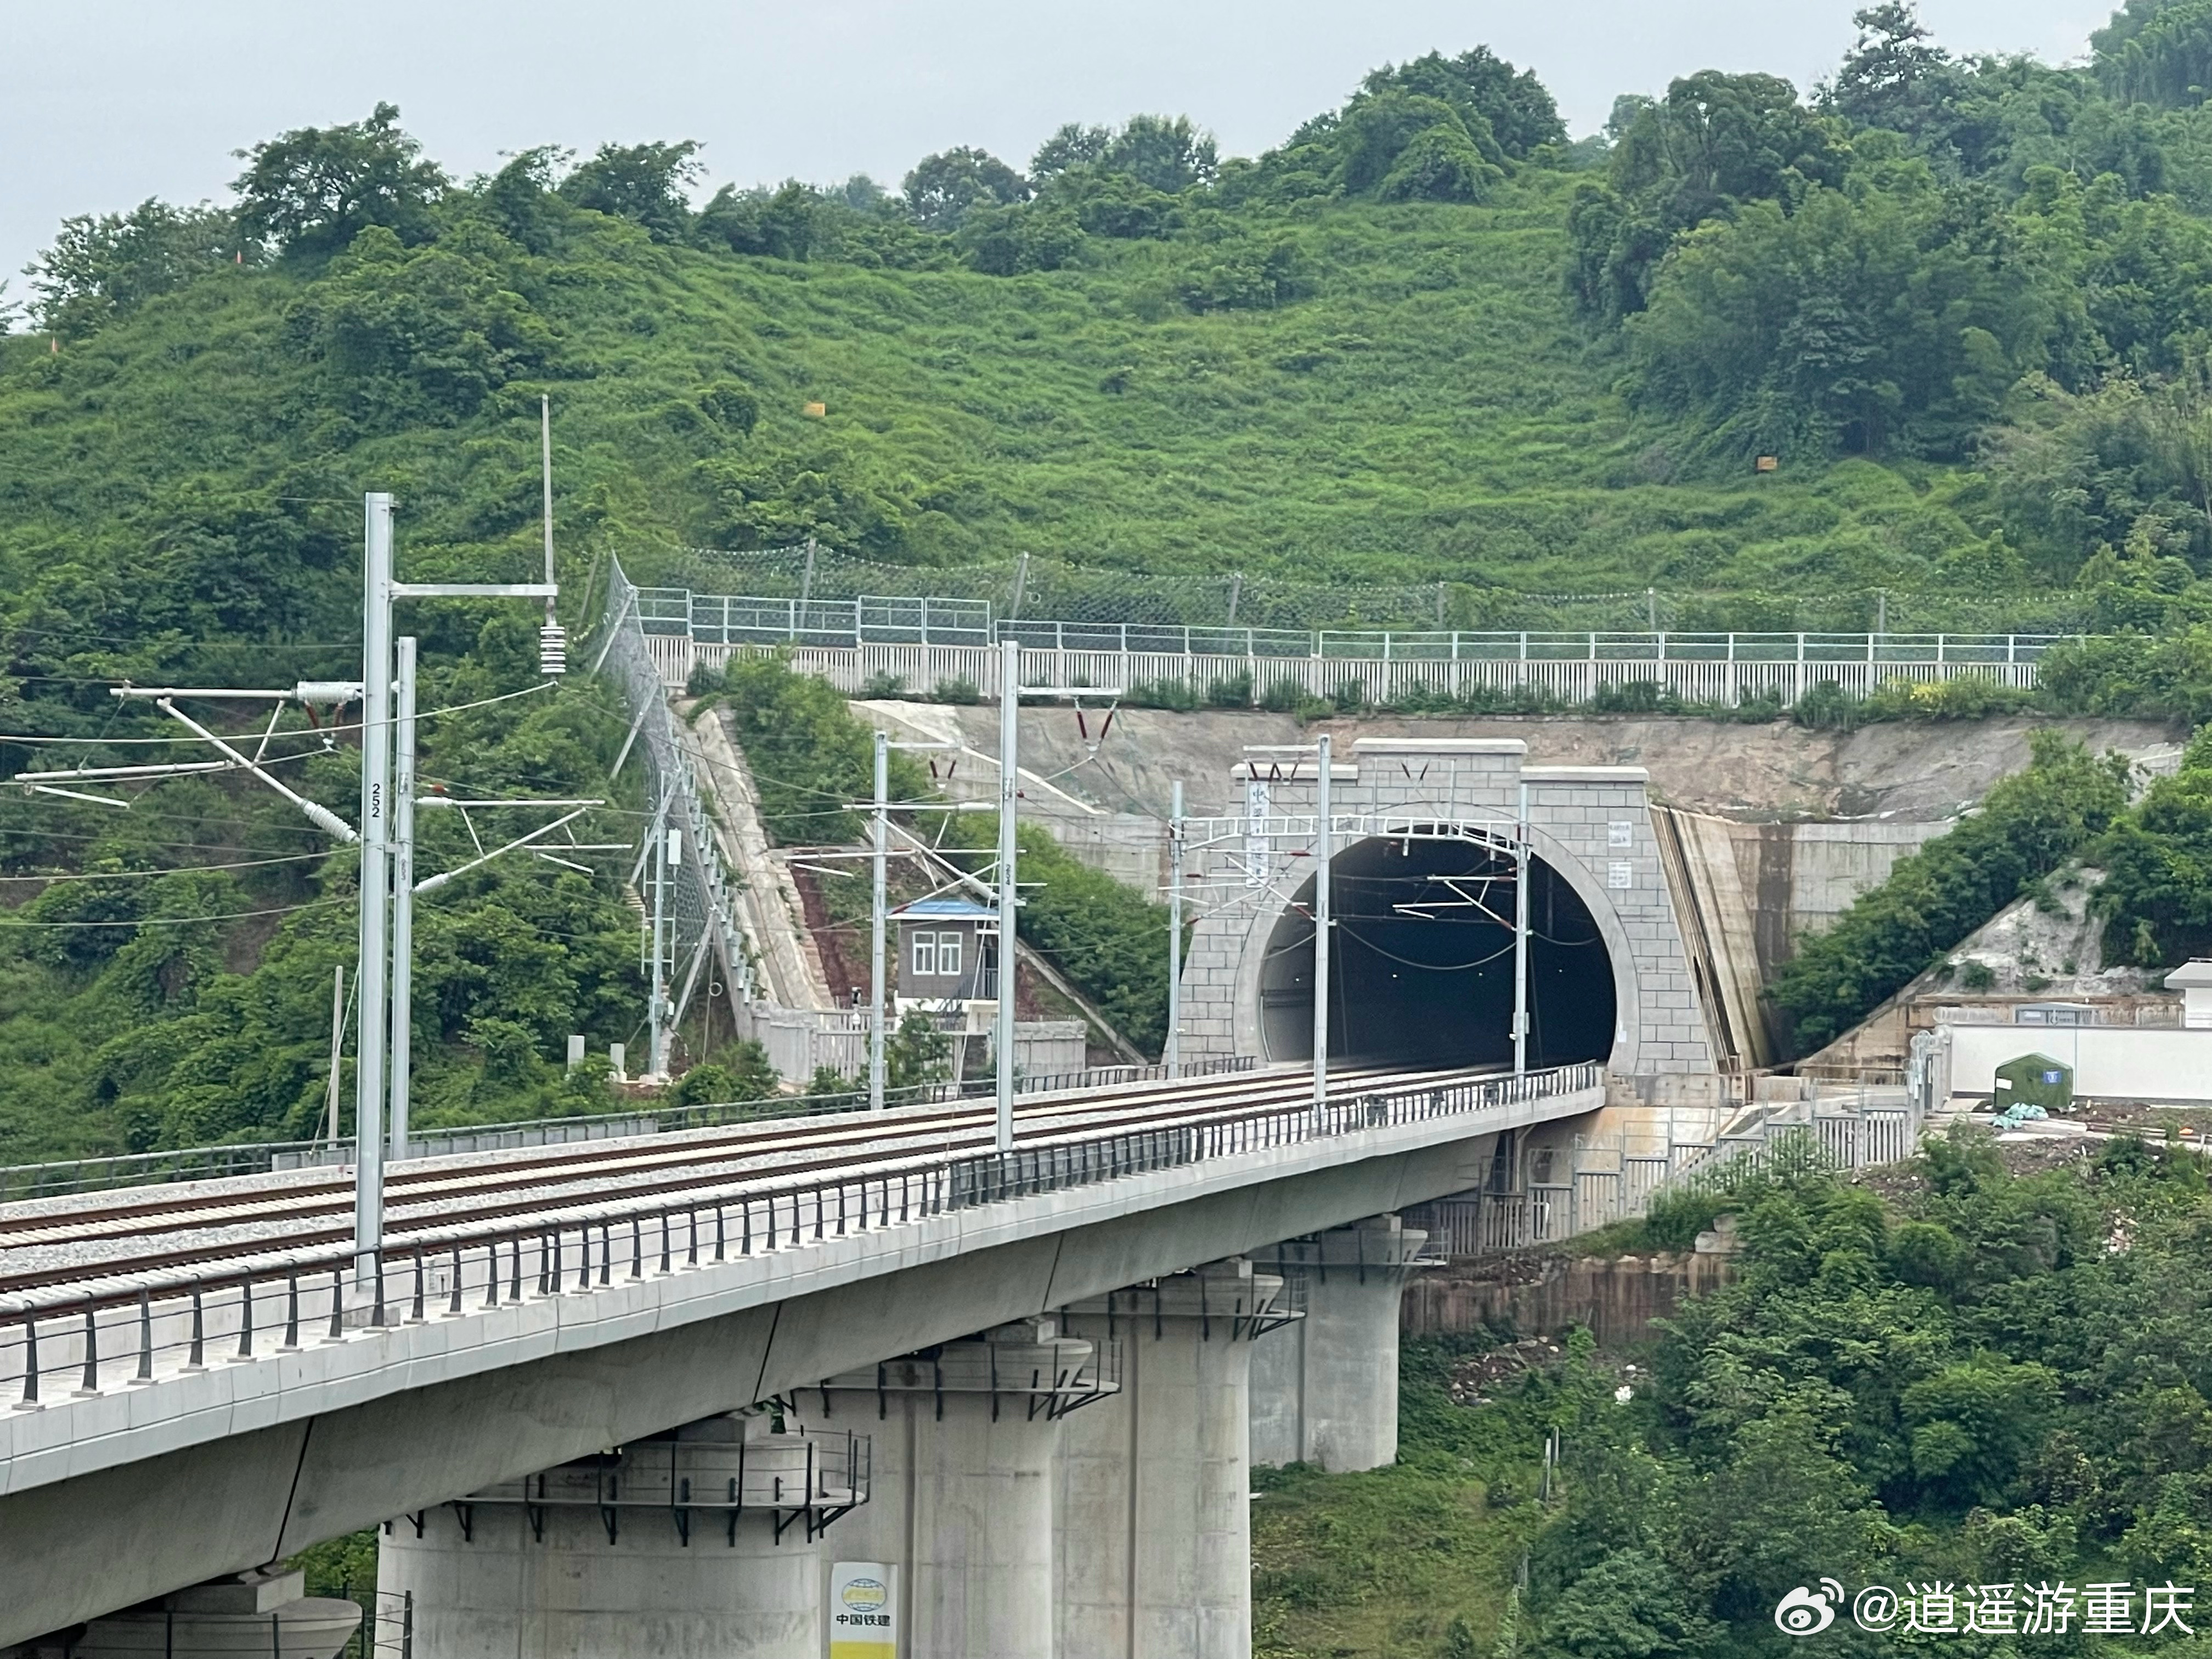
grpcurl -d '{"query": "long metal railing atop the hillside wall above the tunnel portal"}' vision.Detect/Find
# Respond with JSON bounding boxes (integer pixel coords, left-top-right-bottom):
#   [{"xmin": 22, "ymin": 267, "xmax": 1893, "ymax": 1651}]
[{"xmin": 637, "ymin": 589, "xmax": 2075, "ymax": 666}]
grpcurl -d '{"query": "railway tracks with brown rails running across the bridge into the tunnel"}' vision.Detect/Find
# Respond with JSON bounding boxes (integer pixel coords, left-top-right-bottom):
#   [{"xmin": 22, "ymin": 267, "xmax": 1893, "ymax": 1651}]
[{"xmin": 0, "ymin": 1068, "xmax": 1498, "ymax": 1296}]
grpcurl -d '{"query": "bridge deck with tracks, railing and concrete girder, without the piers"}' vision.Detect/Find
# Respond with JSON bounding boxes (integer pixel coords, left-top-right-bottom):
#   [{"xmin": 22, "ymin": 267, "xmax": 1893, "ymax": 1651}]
[{"xmin": 0, "ymin": 1066, "xmax": 1604, "ymax": 1646}]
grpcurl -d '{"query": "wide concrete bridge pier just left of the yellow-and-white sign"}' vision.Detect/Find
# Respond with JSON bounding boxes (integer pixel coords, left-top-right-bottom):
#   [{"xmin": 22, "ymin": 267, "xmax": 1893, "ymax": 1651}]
[{"xmin": 376, "ymin": 1415, "xmax": 867, "ymax": 1659}]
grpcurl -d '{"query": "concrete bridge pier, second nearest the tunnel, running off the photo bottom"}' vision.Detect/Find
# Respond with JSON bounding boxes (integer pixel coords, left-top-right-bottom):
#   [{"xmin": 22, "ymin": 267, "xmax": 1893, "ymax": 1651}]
[{"xmin": 1055, "ymin": 1259, "xmax": 1288, "ymax": 1659}]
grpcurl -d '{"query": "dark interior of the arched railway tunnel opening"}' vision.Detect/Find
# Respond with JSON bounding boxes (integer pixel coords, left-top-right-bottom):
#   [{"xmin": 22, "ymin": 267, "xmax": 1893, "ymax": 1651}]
[{"xmin": 1261, "ymin": 838, "xmax": 1615, "ymax": 1066}]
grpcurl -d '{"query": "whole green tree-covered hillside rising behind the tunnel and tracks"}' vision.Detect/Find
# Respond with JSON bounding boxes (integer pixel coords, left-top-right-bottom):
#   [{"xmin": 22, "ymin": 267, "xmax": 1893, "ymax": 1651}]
[{"xmin": 21, "ymin": 0, "xmax": 2212, "ymax": 1159}]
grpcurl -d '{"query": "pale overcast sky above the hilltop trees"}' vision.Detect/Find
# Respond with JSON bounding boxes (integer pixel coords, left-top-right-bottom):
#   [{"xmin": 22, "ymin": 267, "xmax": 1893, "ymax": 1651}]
[{"xmin": 0, "ymin": 0, "xmax": 2111, "ymax": 298}]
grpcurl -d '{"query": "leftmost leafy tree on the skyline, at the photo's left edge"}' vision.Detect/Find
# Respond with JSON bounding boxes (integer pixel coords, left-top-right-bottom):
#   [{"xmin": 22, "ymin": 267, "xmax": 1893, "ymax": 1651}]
[{"xmin": 29, "ymin": 197, "xmax": 244, "ymax": 338}]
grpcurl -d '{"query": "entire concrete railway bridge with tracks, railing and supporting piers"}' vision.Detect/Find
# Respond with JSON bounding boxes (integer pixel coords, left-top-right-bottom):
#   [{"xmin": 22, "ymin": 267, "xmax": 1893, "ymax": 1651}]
[{"xmin": 0, "ymin": 1064, "xmax": 1604, "ymax": 1659}]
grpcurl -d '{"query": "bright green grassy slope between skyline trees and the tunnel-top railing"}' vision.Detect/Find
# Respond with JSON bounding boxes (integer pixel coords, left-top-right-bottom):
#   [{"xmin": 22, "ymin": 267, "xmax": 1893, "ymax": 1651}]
[{"xmin": 0, "ymin": 170, "xmax": 2017, "ymax": 641}]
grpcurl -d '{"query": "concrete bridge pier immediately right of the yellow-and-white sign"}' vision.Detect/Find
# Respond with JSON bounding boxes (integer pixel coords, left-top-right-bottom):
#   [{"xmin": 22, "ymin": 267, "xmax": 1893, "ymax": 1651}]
[{"xmin": 799, "ymin": 1318, "xmax": 1113, "ymax": 1659}]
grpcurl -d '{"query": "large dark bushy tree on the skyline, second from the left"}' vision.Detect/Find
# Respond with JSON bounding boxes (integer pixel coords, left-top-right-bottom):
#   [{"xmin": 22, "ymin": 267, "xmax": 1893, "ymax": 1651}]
[{"xmin": 230, "ymin": 104, "xmax": 447, "ymax": 255}]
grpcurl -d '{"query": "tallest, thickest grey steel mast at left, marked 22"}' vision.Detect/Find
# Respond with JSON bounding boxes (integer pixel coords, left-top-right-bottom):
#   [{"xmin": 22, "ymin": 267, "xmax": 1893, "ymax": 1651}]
[{"xmin": 354, "ymin": 491, "xmax": 392, "ymax": 1288}]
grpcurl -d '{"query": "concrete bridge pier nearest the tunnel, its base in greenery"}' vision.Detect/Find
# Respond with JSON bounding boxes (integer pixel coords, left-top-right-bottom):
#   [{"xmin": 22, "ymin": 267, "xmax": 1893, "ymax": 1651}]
[{"xmin": 1252, "ymin": 1215, "xmax": 1429, "ymax": 1473}]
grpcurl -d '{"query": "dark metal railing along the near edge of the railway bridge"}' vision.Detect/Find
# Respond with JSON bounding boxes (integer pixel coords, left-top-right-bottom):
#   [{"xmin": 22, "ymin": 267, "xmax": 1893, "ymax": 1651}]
[{"xmin": 0, "ymin": 1064, "xmax": 1604, "ymax": 1409}]
